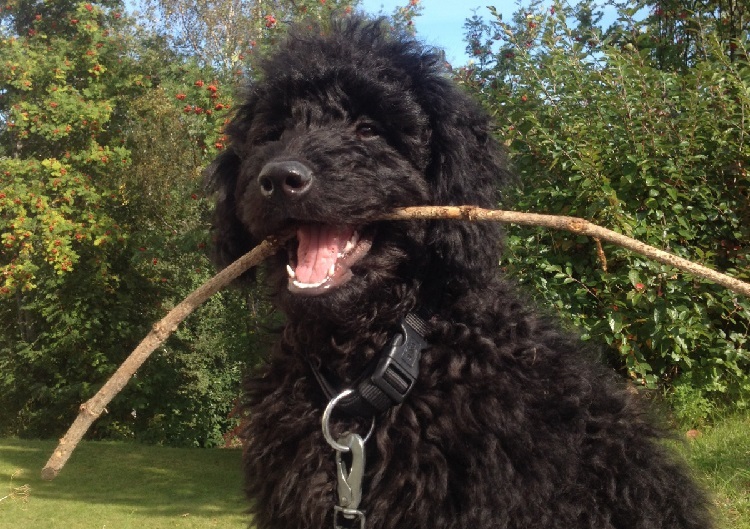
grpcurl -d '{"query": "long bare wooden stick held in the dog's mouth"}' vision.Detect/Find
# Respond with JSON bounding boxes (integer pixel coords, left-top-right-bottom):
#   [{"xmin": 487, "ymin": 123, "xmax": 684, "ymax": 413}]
[{"xmin": 42, "ymin": 206, "xmax": 750, "ymax": 480}]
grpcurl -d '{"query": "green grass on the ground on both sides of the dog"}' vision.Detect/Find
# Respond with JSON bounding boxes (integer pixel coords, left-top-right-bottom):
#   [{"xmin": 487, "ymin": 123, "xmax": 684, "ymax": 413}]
[{"xmin": 0, "ymin": 415, "xmax": 750, "ymax": 529}]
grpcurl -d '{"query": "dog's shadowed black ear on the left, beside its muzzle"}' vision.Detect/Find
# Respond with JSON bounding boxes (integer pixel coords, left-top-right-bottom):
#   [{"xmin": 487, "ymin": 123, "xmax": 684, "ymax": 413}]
[{"xmin": 204, "ymin": 146, "xmax": 259, "ymax": 279}]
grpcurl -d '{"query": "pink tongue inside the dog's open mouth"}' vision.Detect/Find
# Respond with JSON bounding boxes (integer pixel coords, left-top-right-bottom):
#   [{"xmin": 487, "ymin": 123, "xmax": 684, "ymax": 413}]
[{"xmin": 295, "ymin": 224, "xmax": 354, "ymax": 284}]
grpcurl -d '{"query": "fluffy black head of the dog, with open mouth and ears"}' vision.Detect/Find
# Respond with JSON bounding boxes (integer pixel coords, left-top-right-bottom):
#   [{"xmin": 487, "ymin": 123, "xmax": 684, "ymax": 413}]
[{"xmin": 208, "ymin": 18, "xmax": 506, "ymax": 314}]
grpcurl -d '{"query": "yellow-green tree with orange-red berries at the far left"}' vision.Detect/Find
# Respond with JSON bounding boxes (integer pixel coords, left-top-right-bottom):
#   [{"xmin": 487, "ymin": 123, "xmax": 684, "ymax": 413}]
[{"xmin": 0, "ymin": 0, "xmax": 135, "ymax": 296}]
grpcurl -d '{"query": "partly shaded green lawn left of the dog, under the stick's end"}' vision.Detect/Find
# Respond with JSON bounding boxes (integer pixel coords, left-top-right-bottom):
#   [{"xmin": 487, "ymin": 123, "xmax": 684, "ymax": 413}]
[{"xmin": 0, "ymin": 439, "xmax": 248, "ymax": 529}]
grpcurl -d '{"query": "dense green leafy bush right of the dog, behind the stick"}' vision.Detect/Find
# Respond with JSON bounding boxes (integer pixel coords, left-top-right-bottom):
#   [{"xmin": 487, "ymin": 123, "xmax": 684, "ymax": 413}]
[{"xmin": 458, "ymin": 3, "xmax": 750, "ymax": 420}]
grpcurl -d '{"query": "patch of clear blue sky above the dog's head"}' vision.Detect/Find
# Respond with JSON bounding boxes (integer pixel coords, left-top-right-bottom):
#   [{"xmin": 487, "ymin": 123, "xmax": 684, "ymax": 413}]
[{"xmin": 361, "ymin": 0, "xmax": 506, "ymax": 66}]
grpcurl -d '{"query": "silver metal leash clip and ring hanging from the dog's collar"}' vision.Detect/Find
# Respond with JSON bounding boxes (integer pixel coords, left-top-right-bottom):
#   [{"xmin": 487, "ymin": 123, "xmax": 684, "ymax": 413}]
[{"xmin": 322, "ymin": 389, "xmax": 375, "ymax": 529}]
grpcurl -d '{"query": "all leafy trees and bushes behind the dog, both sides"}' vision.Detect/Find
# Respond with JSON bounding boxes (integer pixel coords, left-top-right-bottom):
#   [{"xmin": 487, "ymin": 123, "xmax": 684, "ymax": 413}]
[{"xmin": 0, "ymin": 0, "xmax": 750, "ymax": 446}]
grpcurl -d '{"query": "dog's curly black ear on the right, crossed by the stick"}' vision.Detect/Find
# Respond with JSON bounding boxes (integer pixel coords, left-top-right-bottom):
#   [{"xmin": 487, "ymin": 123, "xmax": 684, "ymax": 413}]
[{"xmin": 426, "ymin": 87, "xmax": 510, "ymax": 288}]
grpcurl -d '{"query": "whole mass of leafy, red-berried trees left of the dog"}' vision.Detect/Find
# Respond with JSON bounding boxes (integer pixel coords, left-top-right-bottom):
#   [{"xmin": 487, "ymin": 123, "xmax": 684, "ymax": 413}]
[{"xmin": 0, "ymin": 2, "xmax": 253, "ymax": 445}]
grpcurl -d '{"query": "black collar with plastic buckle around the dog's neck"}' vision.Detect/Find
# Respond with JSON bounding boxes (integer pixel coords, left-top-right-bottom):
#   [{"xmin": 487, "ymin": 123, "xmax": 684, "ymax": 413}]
[{"xmin": 310, "ymin": 312, "xmax": 428, "ymax": 417}]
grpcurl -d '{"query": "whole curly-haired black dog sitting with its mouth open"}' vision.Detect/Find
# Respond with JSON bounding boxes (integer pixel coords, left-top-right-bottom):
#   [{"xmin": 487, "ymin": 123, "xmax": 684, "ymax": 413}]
[{"xmin": 209, "ymin": 18, "xmax": 711, "ymax": 529}]
